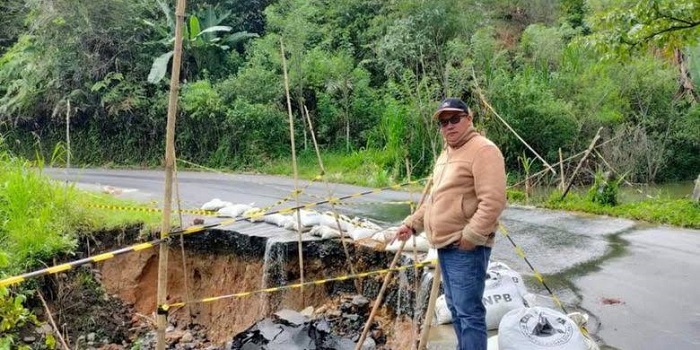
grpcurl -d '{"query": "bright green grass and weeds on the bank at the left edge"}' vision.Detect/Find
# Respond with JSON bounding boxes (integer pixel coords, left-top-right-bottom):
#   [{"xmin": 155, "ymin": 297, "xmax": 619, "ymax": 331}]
[{"xmin": 0, "ymin": 142, "xmax": 158, "ymax": 349}]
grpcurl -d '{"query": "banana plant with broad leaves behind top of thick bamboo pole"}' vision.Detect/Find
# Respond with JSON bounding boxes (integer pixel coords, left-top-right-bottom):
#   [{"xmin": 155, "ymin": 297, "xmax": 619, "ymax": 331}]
[{"xmin": 144, "ymin": 0, "xmax": 258, "ymax": 84}]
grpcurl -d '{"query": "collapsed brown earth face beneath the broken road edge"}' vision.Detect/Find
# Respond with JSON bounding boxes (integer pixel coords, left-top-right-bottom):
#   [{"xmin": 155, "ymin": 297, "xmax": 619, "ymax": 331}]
[{"xmin": 82, "ymin": 224, "xmax": 424, "ymax": 344}]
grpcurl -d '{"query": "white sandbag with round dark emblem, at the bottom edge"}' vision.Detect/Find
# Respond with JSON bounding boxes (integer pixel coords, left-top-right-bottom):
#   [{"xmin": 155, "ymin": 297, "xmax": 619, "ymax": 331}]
[{"xmin": 498, "ymin": 307, "xmax": 588, "ymax": 350}]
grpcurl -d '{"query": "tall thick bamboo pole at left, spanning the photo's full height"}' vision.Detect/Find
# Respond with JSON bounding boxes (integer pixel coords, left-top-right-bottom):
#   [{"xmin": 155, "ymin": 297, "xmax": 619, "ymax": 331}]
[{"xmin": 156, "ymin": 0, "xmax": 185, "ymax": 350}]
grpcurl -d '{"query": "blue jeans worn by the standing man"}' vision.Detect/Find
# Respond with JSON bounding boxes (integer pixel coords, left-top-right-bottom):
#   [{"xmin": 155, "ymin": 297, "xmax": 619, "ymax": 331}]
[{"xmin": 438, "ymin": 245, "xmax": 491, "ymax": 350}]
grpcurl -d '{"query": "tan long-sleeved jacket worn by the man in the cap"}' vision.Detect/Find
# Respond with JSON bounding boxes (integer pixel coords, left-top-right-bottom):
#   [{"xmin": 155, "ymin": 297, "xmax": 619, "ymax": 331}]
[{"xmin": 404, "ymin": 129, "xmax": 506, "ymax": 248}]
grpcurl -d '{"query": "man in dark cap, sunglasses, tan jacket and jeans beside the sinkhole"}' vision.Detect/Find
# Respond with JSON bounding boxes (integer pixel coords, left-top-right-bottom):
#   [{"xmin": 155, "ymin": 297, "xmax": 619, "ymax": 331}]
[{"xmin": 397, "ymin": 98, "xmax": 506, "ymax": 350}]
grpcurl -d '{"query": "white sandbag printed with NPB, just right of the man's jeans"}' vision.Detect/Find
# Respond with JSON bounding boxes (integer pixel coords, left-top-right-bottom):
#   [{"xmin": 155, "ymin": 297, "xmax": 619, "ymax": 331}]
[{"xmin": 482, "ymin": 270, "xmax": 525, "ymax": 330}]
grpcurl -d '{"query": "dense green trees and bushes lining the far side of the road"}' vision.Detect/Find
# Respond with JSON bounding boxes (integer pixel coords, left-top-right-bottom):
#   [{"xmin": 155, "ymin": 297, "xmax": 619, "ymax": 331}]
[{"xmin": 0, "ymin": 0, "xmax": 700, "ymax": 182}]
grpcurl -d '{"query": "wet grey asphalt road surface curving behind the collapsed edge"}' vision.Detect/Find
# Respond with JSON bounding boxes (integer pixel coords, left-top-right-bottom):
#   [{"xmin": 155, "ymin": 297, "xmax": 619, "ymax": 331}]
[{"xmin": 45, "ymin": 169, "xmax": 700, "ymax": 350}]
